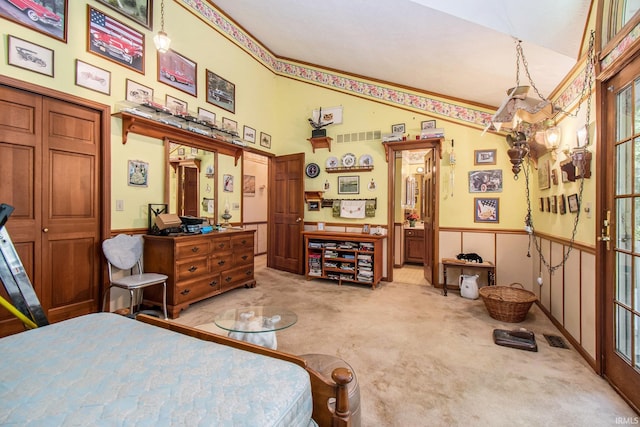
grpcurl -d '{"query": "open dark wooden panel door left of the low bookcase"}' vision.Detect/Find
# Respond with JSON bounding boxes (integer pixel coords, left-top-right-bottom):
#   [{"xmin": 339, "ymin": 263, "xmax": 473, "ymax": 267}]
[{"xmin": 267, "ymin": 154, "xmax": 304, "ymax": 274}]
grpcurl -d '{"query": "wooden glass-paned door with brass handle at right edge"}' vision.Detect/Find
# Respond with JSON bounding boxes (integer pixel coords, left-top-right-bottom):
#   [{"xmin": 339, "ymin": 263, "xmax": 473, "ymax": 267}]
[{"xmin": 597, "ymin": 56, "xmax": 640, "ymax": 408}]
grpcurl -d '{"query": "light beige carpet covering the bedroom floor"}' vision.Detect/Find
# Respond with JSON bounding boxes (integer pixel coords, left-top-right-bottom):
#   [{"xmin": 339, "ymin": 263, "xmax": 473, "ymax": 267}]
[{"xmin": 171, "ymin": 257, "xmax": 637, "ymax": 427}]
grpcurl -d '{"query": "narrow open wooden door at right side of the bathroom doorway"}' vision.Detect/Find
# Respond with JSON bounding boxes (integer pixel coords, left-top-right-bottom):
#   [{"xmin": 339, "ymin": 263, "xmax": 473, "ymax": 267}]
[{"xmin": 422, "ymin": 147, "xmax": 438, "ymax": 284}]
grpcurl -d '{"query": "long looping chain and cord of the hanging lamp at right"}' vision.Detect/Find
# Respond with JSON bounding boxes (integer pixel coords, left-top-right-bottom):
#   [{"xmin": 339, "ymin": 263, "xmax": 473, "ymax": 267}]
[{"xmin": 516, "ymin": 31, "xmax": 595, "ymax": 274}]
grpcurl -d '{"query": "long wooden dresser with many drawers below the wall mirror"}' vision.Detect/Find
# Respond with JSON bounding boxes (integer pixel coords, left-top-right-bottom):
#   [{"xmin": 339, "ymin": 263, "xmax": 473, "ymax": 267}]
[{"xmin": 144, "ymin": 230, "xmax": 256, "ymax": 319}]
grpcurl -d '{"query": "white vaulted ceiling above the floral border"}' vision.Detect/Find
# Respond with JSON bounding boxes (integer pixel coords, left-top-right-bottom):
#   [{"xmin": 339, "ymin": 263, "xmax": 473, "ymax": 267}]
[{"xmin": 213, "ymin": 0, "xmax": 591, "ymax": 107}]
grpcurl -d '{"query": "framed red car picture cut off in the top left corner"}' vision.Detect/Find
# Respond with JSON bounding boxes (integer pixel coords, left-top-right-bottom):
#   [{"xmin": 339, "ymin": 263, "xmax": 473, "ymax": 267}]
[{"xmin": 0, "ymin": 0, "xmax": 69, "ymax": 43}]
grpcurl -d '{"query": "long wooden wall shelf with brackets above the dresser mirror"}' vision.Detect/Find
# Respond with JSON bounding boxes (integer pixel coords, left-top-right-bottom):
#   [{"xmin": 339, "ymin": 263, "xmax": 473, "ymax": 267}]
[{"xmin": 113, "ymin": 112, "xmax": 243, "ymax": 166}]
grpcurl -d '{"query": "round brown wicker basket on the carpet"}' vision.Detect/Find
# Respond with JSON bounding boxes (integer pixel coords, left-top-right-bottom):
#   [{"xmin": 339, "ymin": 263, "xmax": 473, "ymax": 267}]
[{"xmin": 479, "ymin": 283, "xmax": 538, "ymax": 323}]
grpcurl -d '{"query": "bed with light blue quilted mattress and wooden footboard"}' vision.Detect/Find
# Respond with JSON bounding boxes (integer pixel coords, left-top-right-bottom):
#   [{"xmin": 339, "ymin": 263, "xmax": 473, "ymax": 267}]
[{"xmin": 0, "ymin": 313, "xmax": 351, "ymax": 427}]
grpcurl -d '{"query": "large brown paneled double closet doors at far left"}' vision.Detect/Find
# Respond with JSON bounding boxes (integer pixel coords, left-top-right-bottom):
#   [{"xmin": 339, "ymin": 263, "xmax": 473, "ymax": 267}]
[{"xmin": 0, "ymin": 86, "xmax": 103, "ymax": 334}]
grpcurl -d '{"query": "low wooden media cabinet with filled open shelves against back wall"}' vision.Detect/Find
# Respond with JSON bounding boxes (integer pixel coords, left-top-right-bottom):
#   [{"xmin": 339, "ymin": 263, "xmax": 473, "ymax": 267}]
[{"xmin": 302, "ymin": 231, "xmax": 386, "ymax": 289}]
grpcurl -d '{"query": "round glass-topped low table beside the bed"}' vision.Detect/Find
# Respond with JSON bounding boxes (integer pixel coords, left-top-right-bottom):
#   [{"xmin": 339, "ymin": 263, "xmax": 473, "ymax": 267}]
[{"xmin": 214, "ymin": 306, "xmax": 298, "ymax": 350}]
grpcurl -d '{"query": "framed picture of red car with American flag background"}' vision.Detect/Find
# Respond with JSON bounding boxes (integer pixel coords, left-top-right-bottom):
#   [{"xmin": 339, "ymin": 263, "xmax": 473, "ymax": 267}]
[{"xmin": 87, "ymin": 6, "xmax": 144, "ymax": 74}]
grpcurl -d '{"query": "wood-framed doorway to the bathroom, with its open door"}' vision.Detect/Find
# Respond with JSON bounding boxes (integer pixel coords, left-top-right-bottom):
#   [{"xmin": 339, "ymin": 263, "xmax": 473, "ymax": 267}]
[{"xmin": 384, "ymin": 139, "xmax": 442, "ymax": 284}]
